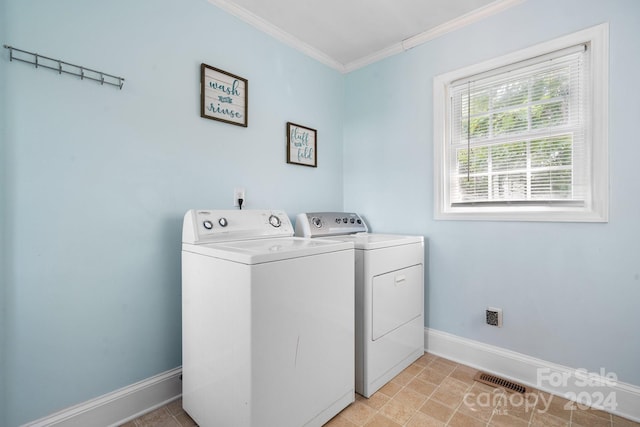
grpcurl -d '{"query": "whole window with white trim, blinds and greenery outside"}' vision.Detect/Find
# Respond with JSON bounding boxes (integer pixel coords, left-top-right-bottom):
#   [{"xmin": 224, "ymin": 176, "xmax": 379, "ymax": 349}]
[{"xmin": 434, "ymin": 24, "xmax": 608, "ymax": 222}]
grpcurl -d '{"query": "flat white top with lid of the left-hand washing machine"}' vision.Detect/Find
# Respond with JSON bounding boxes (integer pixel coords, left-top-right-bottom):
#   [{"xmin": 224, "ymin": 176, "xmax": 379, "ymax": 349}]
[{"xmin": 182, "ymin": 237, "xmax": 354, "ymax": 264}]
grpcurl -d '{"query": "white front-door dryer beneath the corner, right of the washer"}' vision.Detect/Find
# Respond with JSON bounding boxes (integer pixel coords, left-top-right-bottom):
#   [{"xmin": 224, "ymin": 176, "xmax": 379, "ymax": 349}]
[{"xmin": 295, "ymin": 212, "xmax": 424, "ymax": 397}]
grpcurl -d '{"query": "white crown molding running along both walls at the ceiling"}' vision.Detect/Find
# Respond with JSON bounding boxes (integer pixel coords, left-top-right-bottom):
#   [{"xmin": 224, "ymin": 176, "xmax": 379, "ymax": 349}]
[{"xmin": 208, "ymin": 0, "xmax": 526, "ymax": 74}]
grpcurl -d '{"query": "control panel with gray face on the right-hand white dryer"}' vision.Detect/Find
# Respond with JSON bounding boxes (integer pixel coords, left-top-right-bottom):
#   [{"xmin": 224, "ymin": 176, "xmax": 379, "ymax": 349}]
[{"xmin": 295, "ymin": 212, "xmax": 369, "ymax": 237}]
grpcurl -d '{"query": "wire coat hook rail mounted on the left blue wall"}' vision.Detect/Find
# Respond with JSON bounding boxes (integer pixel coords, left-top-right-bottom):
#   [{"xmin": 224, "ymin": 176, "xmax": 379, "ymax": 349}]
[{"xmin": 4, "ymin": 45, "xmax": 124, "ymax": 89}]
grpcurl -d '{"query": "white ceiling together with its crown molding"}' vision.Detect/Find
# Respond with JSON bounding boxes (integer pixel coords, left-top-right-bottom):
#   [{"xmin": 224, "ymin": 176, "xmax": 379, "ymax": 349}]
[{"xmin": 209, "ymin": 0, "xmax": 524, "ymax": 72}]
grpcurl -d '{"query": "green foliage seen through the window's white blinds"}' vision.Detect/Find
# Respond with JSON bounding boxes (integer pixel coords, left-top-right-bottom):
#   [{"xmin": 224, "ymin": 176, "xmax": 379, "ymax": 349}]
[{"xmin": 456, "ymin": 68, "xmax": 573, "ymax": 201}]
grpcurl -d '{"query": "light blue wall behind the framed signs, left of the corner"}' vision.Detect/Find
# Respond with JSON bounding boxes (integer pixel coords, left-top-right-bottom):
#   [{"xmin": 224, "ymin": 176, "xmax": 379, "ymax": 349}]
[{"xmin": 0, "ymin": 0, "xmax": 344, "ymax": 426}]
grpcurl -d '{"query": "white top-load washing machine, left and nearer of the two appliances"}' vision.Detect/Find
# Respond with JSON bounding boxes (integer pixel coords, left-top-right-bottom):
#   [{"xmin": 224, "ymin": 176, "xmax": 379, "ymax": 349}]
[{"xmin": 182, "ymin": 210, "xmax": 355, "ymax": 427}]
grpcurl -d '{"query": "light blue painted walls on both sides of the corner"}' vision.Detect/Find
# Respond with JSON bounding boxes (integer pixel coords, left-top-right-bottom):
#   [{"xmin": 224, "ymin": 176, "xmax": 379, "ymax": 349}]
[{"xmin": 5, "ymin": 0, "xmax": 640, "ymax": 426}]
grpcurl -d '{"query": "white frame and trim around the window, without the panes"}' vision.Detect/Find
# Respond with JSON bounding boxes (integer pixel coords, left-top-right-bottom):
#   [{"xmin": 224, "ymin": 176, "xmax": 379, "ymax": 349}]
[{"xmin": 433, "ymin": 23, "xmax": 609, "ymax": 222}]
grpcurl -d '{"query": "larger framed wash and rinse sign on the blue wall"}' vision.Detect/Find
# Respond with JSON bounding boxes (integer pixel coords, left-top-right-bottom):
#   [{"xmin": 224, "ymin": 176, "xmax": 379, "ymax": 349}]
[{"xmin": 200, "ymin": 64, "xmax": 249, "ymax": 127}]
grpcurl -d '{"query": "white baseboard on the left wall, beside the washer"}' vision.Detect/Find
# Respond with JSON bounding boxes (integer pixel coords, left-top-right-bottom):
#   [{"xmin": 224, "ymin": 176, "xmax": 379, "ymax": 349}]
[{"xmin": 23, "ymin": 368, "xmax": 182, "ymax": 427}]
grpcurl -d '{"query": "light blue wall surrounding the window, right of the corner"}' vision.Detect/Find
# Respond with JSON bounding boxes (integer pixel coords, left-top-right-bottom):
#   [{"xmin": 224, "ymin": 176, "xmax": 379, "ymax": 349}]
[{"xmin": 344, "ymin": 0, "xmax": 640, "ymax": 385}]
